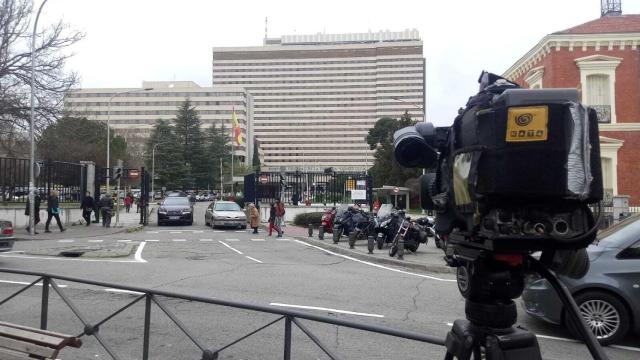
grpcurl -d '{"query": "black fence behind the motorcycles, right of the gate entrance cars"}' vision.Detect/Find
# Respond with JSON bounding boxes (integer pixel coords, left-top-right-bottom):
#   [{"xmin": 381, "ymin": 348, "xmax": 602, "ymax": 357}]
[{"xmin": 244, "ymin": 171, "xmax": 373, "ymax": 205}]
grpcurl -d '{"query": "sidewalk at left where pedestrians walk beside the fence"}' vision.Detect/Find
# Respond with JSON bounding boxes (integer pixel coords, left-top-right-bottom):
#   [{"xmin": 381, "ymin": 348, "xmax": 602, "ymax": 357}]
[{"xmin": 14, "ymin": 208, "xmax": 142, "ymax": 241}]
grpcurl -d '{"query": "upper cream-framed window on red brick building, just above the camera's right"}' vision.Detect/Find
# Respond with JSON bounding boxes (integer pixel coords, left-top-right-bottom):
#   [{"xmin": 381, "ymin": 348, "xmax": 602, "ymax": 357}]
[{"xmin": 575, "ymin": 55, "xmax": 622, "ymax": 124}]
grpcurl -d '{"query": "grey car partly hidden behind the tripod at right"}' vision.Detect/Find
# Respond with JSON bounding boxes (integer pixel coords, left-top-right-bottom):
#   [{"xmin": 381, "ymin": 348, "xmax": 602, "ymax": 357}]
[{"xmin": 522, "ymin": 214, "xmax": 640, "ymax": 345}]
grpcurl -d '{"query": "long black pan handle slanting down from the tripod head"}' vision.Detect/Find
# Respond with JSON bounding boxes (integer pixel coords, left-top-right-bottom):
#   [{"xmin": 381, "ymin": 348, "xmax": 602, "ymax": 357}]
[{"xmin": 529, "ymin": 256, "xmax": 609, "ymax": 360}]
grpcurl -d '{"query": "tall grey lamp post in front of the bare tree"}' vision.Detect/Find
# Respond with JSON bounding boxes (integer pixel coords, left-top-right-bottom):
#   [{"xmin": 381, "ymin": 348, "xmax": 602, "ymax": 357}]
[{"xmin": 28, "ymin": 0, "xmax": 47, "ymax": 235}]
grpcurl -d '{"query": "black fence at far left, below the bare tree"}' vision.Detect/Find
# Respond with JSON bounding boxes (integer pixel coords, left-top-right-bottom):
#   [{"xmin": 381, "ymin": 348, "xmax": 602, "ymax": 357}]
[{"xmin": 0, "ymin": 158, "xmax": 87, "ymax": 202}]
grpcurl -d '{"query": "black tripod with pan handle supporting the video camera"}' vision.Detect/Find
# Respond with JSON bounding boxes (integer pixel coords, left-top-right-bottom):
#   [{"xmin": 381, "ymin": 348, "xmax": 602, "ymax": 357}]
[{"xmin": 445, "ymin": 254, "xmax": 607, "ymax": 360}]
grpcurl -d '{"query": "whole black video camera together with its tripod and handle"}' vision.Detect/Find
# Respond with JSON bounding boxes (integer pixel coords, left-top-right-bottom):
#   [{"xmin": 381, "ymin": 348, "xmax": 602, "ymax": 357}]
[{"xmin": 394, "ymin": 72, "xmax": 606, "ymax": 359}]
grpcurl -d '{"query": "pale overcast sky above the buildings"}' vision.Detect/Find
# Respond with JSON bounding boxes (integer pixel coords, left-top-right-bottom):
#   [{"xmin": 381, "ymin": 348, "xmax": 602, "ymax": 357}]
[{"xmin": 42, "ymin": 0, "xmax": 640, "ymax": 125}]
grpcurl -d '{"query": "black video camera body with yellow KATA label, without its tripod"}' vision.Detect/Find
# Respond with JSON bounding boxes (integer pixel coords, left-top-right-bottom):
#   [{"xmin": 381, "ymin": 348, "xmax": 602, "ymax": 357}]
[{"xmin": 394, "ymin": 72, "xmax": 603, "ymax": 253}]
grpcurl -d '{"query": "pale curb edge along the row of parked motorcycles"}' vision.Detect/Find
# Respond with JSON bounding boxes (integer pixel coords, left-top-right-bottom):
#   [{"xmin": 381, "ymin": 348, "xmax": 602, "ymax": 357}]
[{"xmin": 276, "ymin": 226, "xmax": 456, "ymax": 274}]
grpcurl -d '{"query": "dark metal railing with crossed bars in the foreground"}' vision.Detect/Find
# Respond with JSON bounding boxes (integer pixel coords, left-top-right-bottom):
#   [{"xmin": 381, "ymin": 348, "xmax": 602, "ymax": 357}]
[{"xmin": 0, "ymin": 269, "xmax": 445, "ymax": 360}]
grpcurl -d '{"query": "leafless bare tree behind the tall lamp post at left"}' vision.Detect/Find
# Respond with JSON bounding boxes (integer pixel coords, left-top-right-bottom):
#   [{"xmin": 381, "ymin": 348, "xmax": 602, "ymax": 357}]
[{"xmin": 0, "ymin": 0, "xmax": 84, "ymax": 154}]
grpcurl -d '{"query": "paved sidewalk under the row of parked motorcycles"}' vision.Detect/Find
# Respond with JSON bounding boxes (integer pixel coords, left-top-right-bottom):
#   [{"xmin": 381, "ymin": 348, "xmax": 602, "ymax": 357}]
[{"xmin": 284, "ymin": 224, "xmax": 455, "ymax": 273}]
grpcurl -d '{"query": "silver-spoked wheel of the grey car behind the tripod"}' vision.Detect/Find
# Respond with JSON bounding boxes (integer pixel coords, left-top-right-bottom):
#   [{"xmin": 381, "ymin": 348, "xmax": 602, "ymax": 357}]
[{"xmin": 564, "ymin": 291, "xmax": 630, "ymax": 345}]
